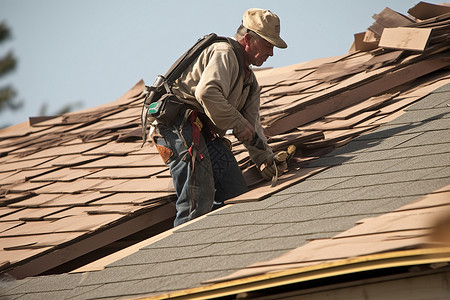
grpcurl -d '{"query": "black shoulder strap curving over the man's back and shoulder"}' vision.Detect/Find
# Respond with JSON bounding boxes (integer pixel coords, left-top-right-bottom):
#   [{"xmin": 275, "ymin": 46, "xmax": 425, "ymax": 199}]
[{"xmin": 164, "ymin": 33, "xmax": 244, "ymax": 90}]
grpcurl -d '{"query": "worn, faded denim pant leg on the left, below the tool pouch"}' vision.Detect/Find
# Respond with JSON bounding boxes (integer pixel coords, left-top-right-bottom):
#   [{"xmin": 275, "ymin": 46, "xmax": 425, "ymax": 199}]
[{"xmin": 155, "ymin": 120, "xmax": 214, "ymax": 226}]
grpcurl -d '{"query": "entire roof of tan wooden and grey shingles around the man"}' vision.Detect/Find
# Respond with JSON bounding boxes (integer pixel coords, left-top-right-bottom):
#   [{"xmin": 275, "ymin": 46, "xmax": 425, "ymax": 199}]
[{"xmin": 0, "ymin": 4, "xmax": 450, "ymax": 299}]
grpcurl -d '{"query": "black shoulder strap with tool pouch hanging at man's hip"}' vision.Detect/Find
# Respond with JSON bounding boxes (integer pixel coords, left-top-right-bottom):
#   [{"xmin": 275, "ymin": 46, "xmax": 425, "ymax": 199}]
[{"xmin": 141, "ymin": 33, "xmax": 244, "ymax": 147}]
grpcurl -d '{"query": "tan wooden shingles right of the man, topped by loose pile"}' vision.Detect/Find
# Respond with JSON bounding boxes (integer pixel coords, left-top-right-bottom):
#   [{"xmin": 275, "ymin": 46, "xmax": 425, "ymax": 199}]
[{"xmin": 228, "ymin": 2, "xmax": 450, "ymax": 199}]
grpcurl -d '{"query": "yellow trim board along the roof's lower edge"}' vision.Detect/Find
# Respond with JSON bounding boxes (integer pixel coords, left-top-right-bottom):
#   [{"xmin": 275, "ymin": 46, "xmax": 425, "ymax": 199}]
[{"xmin": 139, "ymin": 247, "xmax": 450, "ymax": 300}]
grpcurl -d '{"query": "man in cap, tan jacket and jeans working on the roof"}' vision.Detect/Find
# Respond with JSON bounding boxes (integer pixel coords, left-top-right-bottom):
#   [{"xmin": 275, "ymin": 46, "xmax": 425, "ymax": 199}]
[{"xmin": 153, "ymin": 9, "xmax": 287, "ymax": 226}]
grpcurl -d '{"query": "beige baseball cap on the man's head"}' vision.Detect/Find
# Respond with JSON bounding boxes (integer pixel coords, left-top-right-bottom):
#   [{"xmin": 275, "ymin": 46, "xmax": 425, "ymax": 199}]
[{"xmin": 242, "ymin": 8, "xmax": 287, "ymax": 48}]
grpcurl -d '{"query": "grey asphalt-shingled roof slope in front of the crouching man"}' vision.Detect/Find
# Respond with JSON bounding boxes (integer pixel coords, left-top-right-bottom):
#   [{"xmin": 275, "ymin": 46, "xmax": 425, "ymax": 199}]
[{"xmin": 4, "ymin": 79, "xmax": 450, "ymax": 299}]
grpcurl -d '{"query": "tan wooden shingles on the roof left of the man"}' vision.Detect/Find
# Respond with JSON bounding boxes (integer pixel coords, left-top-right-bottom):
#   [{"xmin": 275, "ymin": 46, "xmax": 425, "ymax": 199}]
[{"xmin": 0, "ymin": 81, "xmax": 173, "ymax": 271}]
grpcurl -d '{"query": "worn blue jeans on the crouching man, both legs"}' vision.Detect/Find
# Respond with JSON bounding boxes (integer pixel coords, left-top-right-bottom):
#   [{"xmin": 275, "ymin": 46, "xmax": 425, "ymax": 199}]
[{"xmin": 154, "ymin": 113, "xmax": 248, "ymax": 226}]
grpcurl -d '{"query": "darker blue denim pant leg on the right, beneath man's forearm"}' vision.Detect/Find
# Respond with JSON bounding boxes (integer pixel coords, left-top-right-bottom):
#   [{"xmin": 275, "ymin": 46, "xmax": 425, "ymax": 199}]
[{"xmin": 207, "ymin": 138, "xmax": 248, "ymax": 209}]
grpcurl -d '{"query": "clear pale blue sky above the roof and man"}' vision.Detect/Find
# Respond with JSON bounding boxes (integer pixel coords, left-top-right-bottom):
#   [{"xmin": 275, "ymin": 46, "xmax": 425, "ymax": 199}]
[{"xmin": 0, "ymin": 0, "xmax": 436, "ymax": 126}]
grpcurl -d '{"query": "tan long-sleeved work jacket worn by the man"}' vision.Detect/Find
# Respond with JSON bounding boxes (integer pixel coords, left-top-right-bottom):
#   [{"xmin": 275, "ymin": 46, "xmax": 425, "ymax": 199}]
[{"xmin": 173, "ymin": 42, "xmax": 273, "ymax": 166}]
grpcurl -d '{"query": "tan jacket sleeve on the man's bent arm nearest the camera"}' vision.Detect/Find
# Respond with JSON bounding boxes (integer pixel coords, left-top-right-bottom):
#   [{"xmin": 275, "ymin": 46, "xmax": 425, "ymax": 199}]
[{"xmin": 195, "ymin": 47, "xmax": 250, "ymax": 132}]
